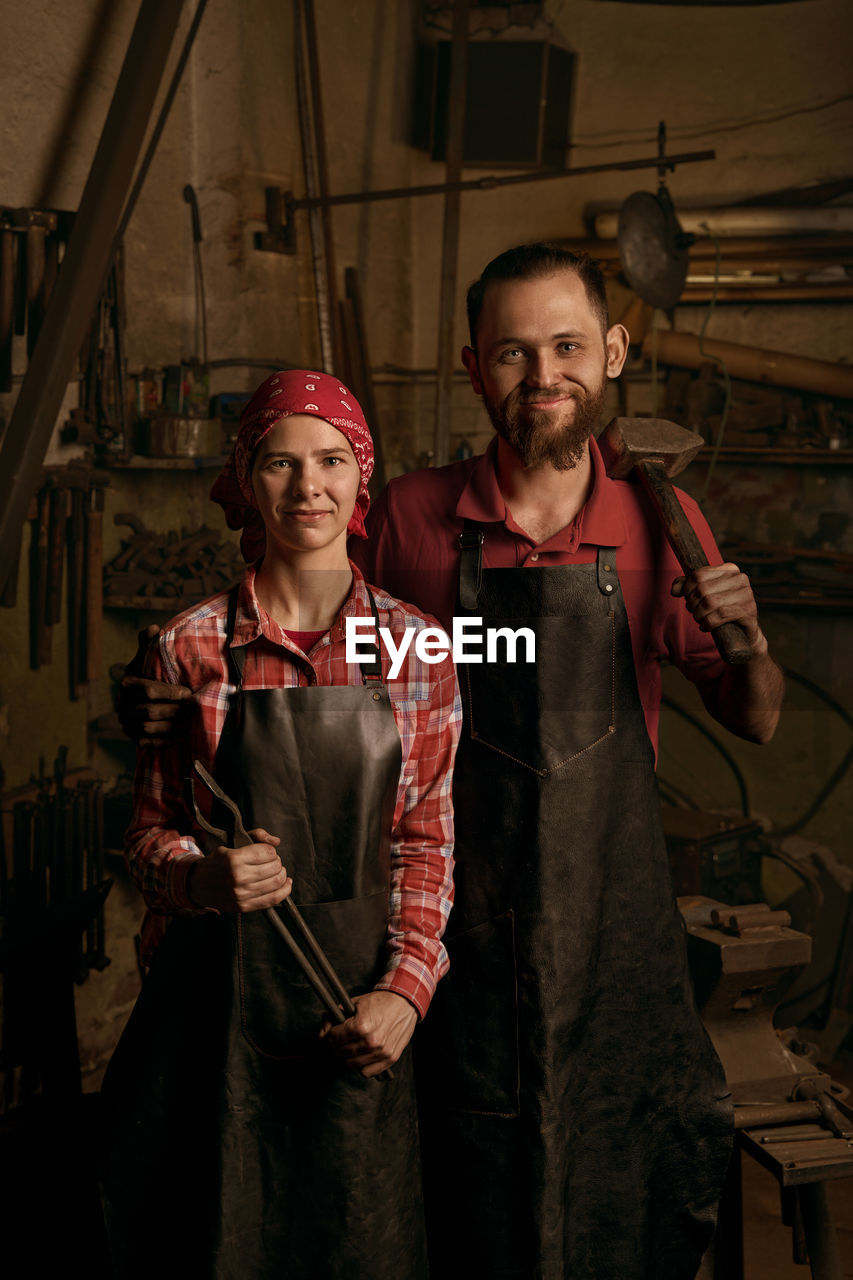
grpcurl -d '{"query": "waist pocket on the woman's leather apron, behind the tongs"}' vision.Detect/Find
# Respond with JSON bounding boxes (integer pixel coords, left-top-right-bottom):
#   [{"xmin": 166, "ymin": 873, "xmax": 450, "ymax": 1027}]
[{"xmin": 237, "ymin": 890, "xmax": 388, "ymax": 1059}]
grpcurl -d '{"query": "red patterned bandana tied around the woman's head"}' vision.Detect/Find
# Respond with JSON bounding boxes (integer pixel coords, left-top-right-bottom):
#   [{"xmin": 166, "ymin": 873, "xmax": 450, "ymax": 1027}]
[{"xmin": 210, "ymin": 369, "xmax": 373, "ymax": 563}]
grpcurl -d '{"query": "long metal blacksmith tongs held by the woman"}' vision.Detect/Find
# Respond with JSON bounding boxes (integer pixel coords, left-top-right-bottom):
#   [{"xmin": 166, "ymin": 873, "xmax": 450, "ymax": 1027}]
[{"xmin": 190, "ymin": 760, "xmax": 356, "ymax": 1023}]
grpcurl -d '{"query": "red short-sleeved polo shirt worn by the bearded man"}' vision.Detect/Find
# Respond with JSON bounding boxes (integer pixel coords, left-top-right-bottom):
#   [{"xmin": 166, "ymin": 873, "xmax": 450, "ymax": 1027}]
[{"xmin": 350, "ymin": 440, "xmax": 725, "ymax": 750}]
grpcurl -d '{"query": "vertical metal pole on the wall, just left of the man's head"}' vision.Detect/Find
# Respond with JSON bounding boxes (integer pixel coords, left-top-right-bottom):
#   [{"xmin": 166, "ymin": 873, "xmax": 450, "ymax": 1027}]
[{"xmin": 433, "ymin": 0, "xmax": 469, "ymax": 467}]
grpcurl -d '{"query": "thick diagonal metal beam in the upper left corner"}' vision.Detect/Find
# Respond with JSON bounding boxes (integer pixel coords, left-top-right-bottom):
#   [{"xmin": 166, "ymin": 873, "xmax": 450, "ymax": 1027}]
[{"xmin": 0, "ymin": 0, "xmax": 183, "ymax": 566}]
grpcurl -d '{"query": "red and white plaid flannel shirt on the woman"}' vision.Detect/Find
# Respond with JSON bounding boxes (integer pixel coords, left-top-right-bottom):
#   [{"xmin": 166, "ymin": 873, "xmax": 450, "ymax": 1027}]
[{"xmin": 126, "ymin": 566, "xmax": 461, "ymax": 1016}]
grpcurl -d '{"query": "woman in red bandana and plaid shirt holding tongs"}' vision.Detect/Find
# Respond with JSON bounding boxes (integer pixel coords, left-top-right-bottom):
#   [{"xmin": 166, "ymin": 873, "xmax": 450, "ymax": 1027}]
[{"xmin": 101, "ymin": 370, "xmax": 460, "ymax": 1280}]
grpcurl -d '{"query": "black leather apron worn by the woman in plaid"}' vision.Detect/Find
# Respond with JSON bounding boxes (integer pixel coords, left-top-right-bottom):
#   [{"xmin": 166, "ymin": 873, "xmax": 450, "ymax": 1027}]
[{"xmin": 101, "ymin": 595, "xmax": 427, "ymax": 1280}]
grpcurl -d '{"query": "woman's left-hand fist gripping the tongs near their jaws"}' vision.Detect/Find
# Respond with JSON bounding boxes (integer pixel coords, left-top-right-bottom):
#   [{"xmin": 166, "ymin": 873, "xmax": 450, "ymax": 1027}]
[{"xmin": 187, "ymin": 827, "xmax": 293, "ymax": 911}]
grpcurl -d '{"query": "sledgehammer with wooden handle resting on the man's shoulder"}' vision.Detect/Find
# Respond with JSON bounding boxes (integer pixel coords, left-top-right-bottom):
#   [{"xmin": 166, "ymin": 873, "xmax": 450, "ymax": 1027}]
[{"xmin": 598, "ymin": 417, "xmax": 752, "ymax": 666}]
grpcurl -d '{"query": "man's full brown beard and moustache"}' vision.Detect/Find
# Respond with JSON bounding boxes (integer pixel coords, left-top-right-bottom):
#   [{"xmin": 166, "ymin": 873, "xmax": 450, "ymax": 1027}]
[{"xmin": 483, "ymin": 372, "xmax": 607, "ymax": 471}]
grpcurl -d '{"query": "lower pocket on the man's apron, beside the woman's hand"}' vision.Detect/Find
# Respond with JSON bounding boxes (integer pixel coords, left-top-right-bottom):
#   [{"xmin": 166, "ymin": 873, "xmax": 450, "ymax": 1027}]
[{"xmin": 419, "ymin": 911, "xmax": 519, "ymax": 1116}]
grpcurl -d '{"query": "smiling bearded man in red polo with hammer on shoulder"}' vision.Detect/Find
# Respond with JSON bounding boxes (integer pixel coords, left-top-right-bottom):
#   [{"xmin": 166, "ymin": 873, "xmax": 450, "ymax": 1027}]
[{"xmin": 348, "ymin": 244, "xmax": 783, "ymax": 1280}]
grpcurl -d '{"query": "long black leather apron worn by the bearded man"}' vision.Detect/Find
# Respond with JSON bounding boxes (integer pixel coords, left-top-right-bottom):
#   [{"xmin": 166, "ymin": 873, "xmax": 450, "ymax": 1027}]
[{"xmin": 418, "ymin": 526, "xmax": 731, "ymax": 1280}]
